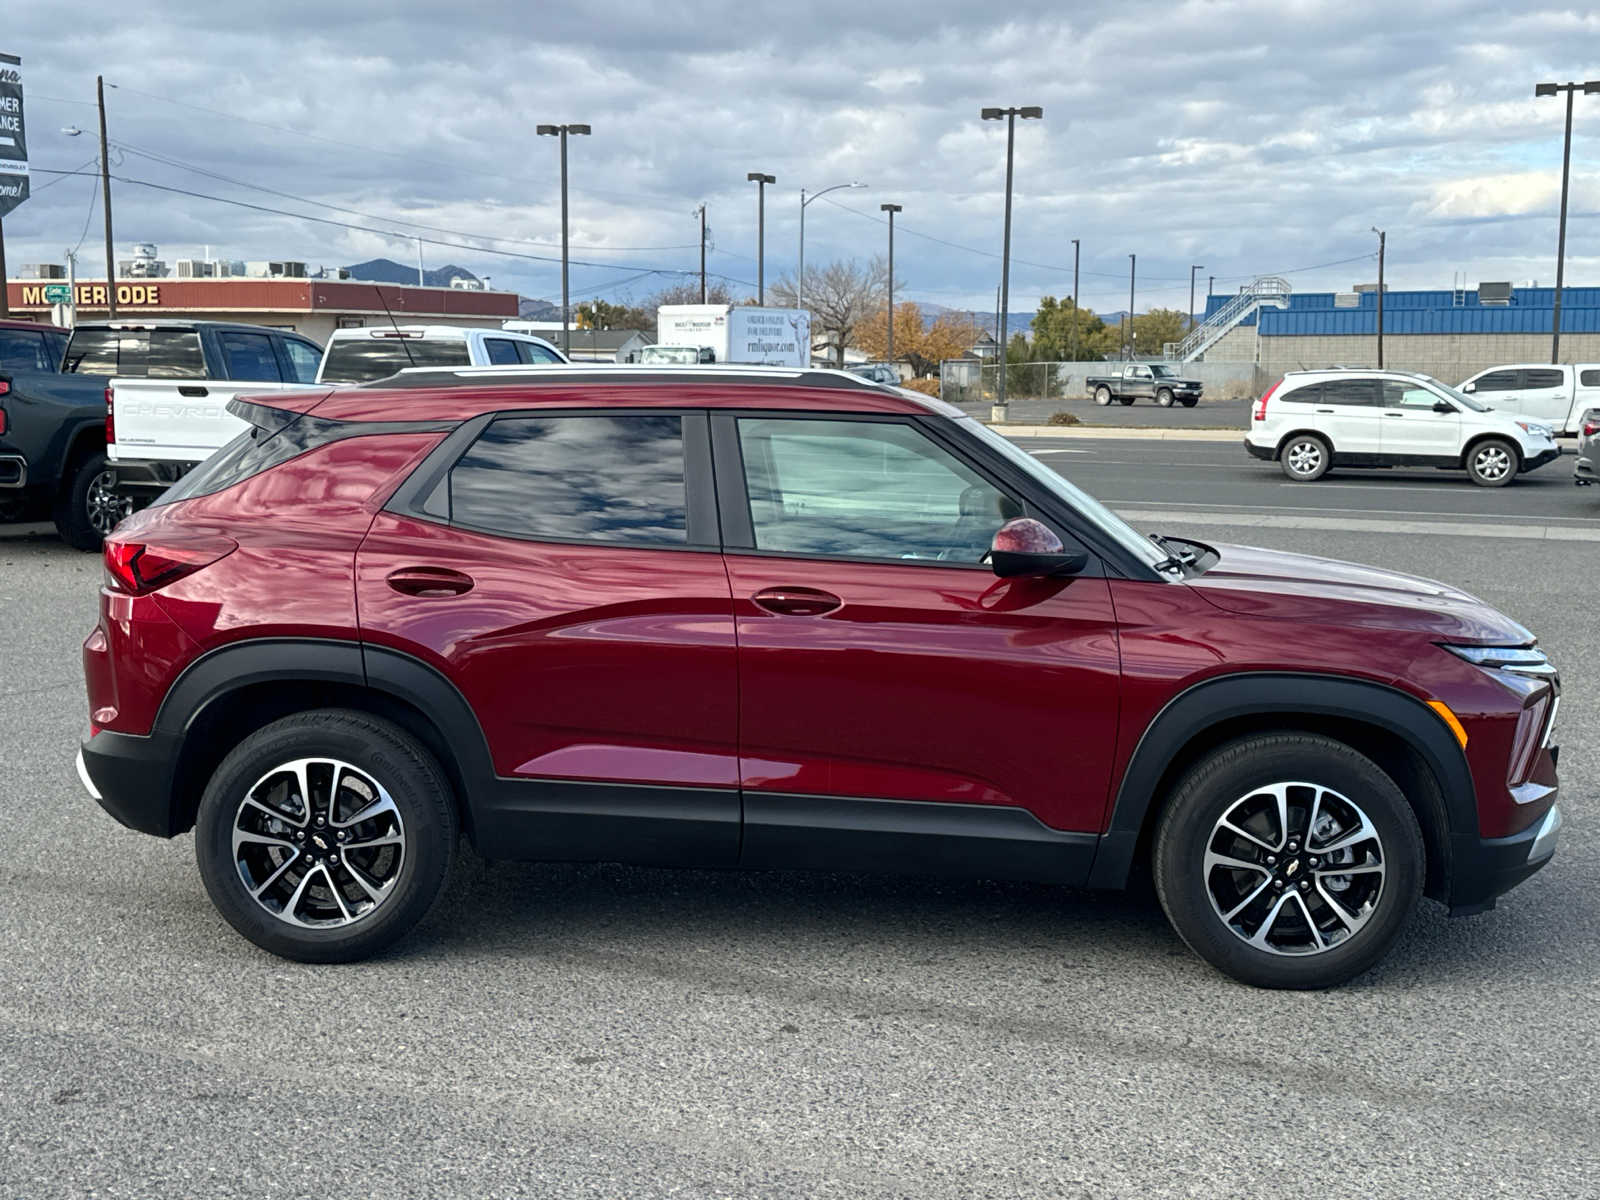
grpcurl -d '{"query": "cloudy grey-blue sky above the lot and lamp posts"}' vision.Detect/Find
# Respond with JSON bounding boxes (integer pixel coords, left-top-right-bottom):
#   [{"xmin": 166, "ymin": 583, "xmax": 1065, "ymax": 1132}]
[{"xmin": 0, "ymin": 0, "xmax": 1600, "ymax": 310}]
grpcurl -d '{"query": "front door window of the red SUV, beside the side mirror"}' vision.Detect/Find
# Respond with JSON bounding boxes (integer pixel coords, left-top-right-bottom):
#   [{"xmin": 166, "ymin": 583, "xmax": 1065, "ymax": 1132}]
[{"xmin": 739, "ymin": 418, "xmax": 1024, "ymax": 563}]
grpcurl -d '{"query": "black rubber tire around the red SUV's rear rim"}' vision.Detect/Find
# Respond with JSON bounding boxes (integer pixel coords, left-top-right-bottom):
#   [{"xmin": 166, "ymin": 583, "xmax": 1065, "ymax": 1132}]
[{"xmin": 195, "ymin": 709, "xmax": 458, "ymax": 963}]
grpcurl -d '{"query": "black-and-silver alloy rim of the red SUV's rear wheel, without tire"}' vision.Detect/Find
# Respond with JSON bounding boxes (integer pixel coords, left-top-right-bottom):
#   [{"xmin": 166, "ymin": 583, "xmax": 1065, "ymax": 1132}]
[{"xmin": 232, "ymin": 758, "xmax": 406, "ymax": 930}]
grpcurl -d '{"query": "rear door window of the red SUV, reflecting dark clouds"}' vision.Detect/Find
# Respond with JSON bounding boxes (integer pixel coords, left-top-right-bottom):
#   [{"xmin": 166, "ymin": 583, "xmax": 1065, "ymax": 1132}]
[{"xmin": 450, "ymin": 413, "xmax": 688, "ymax": 546}]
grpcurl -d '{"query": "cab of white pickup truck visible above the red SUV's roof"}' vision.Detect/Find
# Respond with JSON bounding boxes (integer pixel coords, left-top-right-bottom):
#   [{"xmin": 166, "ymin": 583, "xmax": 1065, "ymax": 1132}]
[{"xmin": 315, "ymin": 325, "xmax": 566, "ymax": 385}]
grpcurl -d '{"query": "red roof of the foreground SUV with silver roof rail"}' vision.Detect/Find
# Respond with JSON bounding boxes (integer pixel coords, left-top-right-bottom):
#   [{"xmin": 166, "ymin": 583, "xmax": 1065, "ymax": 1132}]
[{"xmin": 310, "ymin": 363, "xmax": 962, "ymax": 421}]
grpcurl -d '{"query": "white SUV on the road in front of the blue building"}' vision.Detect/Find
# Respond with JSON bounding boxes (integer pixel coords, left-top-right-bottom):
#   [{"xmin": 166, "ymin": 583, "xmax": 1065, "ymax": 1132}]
[{"xmin": 1245, "ymin": 368, "xmax": 1562, "ymax": 488}]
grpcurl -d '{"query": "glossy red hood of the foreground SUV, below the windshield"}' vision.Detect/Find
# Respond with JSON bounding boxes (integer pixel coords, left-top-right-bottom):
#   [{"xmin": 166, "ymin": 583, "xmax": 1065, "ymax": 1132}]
[{"xmin": 1189, "ymin": 546, "xmax": 1533, "ymax": 645}]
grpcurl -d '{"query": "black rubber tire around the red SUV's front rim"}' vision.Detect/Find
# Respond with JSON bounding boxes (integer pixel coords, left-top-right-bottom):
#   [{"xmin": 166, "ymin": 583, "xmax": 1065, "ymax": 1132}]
[{"xmin": 1152, "ymin": 733, "xmax": 1424, "ymax": 989}]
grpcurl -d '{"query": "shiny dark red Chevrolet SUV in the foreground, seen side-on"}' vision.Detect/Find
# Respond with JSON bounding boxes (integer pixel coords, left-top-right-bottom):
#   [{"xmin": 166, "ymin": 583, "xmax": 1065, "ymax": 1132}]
[{"xmin": 78, "ymin": 368, "xmax": 1562, "ymax": 987}]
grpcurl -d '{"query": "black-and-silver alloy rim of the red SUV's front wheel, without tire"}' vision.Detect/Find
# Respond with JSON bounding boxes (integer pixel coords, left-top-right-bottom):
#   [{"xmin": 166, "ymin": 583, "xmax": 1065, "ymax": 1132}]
[{"xmin": 1202, "ymin": 782, "xmax": 1386, "ymax": 955}]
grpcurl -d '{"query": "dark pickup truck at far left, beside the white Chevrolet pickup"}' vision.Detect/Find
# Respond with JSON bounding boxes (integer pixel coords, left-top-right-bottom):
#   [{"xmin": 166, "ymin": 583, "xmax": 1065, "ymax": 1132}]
[{"xmin": 0, "ymin": 320, "xmax": 320, "ymax": 550}]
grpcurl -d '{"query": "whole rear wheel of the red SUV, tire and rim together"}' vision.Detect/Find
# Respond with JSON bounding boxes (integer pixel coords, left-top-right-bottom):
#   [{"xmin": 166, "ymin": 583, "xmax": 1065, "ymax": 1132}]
[{"xmin": 195, "ymin": 709, "xmax": 458, "ymax": 963}]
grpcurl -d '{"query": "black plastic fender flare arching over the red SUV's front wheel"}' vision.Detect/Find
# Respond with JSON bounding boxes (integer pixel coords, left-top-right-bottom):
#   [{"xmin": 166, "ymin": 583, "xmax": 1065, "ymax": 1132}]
[{"xmin": 1090, "ymin": 672, "xmax": 1478, "ymax": 888}]
